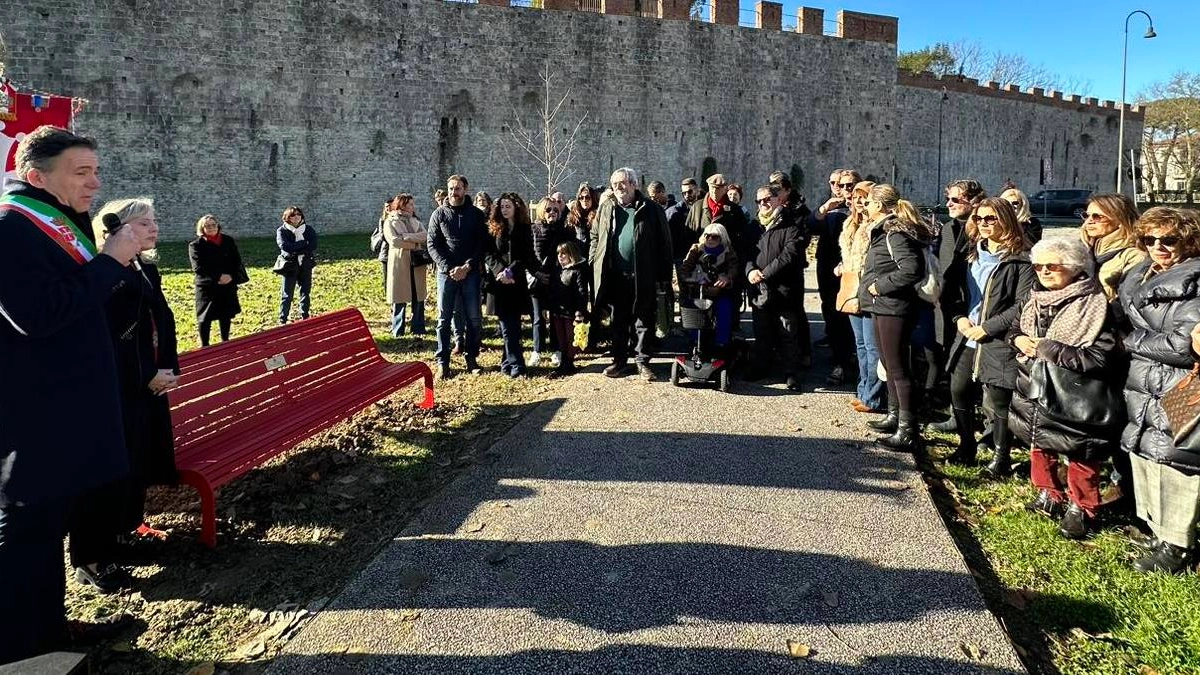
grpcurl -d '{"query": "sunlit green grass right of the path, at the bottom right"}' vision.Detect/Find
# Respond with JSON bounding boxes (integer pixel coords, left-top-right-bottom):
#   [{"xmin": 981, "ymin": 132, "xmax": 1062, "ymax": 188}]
[{"xmin": 925, "ymin": 436, "xmax": 1200, "ymax": 675}]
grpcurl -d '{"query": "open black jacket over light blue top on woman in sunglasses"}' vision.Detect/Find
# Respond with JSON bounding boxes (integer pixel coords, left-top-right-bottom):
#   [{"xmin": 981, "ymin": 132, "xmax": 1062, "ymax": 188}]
[{"xmin": 947, "ymin": 253, "xmax": 1036, "ymax": 389}]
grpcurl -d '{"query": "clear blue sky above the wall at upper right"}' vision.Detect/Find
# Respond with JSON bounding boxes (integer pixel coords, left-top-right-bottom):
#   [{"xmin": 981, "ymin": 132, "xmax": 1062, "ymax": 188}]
[{"xmin": 742, "ymin": 0, "xmax": 1185, "ymax": 101}]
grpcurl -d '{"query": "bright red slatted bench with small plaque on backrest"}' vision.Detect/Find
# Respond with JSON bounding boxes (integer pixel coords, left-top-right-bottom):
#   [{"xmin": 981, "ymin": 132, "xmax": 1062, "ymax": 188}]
[{"xmin": 170, "ymin": 309, "xmax": 433, "ymax": 548}]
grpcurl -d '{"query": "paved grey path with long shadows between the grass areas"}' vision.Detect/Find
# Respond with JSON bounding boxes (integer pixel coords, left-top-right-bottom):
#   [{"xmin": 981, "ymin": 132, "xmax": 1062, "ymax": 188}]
[{"xmin": 269, "ymin": 281, "xmax": 1025, "ymax": 675}]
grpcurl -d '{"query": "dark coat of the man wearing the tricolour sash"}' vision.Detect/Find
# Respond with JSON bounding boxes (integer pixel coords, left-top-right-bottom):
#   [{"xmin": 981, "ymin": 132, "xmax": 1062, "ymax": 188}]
[{"xmin": 0, "ymin": 181, "xmax": 128, "ymax": 508}]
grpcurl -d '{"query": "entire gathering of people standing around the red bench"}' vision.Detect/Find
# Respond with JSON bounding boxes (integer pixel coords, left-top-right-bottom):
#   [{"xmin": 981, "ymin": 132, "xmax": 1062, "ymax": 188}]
[{"xmin": 0, "ymin": 119, "xmax": 1200, "ymax": 663}]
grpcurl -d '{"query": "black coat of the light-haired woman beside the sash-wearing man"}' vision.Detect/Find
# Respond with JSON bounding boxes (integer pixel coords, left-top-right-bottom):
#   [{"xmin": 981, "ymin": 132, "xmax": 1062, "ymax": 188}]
[{"xmin": 104, "ymin": 263, "xmax": 179, "ymax": 492}]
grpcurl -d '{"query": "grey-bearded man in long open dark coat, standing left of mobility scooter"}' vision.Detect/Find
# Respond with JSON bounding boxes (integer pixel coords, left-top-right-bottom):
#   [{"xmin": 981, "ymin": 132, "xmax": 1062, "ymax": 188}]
[{"xmin": 588, "ymin": 167, "xmax": 671, "ymax": 381}]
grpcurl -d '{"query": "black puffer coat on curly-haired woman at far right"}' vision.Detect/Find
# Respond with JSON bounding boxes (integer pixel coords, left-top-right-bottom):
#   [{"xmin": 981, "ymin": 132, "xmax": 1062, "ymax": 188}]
[{"xmin": 1116, "ymin": 258, "xmax": 1200, "ymax": 476}]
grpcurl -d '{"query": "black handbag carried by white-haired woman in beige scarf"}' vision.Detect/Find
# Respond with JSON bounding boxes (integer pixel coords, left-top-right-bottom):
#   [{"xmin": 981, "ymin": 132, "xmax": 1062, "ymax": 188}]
[{"xmin": 1030, "ymin": 359, "xmax": 1126, "ymax": 429}]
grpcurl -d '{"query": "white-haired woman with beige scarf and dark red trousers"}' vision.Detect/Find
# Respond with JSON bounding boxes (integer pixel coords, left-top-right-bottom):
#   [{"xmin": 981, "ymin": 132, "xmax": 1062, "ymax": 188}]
[{"xmin": 1008, "ymin": 239, "xmax": 1126, "ymax": 539}]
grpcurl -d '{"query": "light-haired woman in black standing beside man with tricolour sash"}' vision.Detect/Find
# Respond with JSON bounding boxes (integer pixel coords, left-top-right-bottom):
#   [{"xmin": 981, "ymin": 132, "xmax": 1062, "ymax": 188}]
[{"xmin": 71, "ymin": 197, "xmax": 179, "ymax": 593}]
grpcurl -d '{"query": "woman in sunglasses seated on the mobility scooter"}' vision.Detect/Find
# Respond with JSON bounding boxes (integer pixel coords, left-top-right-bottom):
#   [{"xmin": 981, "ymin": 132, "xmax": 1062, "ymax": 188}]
[{"xmin": 679, "ymin": 222, "xmax": 738, "ymax": 350}]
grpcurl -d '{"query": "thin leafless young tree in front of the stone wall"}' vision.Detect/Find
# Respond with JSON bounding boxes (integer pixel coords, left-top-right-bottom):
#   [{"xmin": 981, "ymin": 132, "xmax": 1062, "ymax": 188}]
[{"xmin": 509, "ymin": 64, "xmax": 588, "ymax": 195}]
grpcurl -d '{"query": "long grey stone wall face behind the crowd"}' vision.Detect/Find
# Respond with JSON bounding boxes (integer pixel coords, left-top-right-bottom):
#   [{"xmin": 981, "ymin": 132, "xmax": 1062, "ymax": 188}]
[{"xmin": 0, "ymin": 0, "xmax": 1141, "ymax": 239}]
